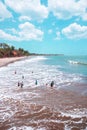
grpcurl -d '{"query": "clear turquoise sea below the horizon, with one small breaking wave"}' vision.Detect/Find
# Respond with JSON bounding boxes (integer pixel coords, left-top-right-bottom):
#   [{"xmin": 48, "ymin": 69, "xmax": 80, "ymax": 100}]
[{"xmin": 42, "ymin": 56, "xmax": 87, "ymax": 76}]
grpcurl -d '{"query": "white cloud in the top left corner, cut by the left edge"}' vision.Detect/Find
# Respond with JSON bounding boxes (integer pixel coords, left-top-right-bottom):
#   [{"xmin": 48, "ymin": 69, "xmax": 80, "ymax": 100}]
[{"xmin": 0, "ymin": 1, "xmax": 12, "ymax": 21}]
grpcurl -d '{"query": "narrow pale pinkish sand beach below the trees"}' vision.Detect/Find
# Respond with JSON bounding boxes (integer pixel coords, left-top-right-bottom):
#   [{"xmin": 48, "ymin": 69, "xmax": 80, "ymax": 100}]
[{"xmin": 0, "ymin": 56, "xmax": 26, "ymax": 67}]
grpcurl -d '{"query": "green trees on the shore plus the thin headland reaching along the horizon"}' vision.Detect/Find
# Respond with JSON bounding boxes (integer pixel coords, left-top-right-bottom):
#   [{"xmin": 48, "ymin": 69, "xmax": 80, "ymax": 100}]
[{"xmin": 0, "ymin": 43, "xmax": 63, "ymax": 58}]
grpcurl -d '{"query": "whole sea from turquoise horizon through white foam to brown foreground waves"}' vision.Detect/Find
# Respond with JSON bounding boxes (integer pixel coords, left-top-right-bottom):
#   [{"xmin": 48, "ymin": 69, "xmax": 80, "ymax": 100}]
[{"xmin": 0, "ymin": 55, "xmax": 87, "ymax": 130}]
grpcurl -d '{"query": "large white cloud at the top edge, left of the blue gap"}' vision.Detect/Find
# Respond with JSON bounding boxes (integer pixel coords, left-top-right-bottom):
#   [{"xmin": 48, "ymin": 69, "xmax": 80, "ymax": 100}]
[{"xmin": 5, "ymin": 0, "xmax": 48, "ymax": 21}]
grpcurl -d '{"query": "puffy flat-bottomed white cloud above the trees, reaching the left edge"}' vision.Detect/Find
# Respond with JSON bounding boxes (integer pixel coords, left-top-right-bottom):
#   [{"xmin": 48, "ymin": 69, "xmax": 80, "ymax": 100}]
[{"xmin": 0, "ymin": 22, "xmax": 44, "ymax": 41}]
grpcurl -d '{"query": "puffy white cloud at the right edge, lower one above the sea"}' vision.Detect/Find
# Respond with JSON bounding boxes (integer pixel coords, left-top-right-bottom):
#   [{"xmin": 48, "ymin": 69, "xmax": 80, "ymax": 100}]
[{"xmin": 62, "ymin": 23, "xmax": 87, "ymax": 39}]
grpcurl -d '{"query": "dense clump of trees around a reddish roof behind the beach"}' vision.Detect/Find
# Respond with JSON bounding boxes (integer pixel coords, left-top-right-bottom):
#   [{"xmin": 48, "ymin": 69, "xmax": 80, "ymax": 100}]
[{"xmin": 0, "ymin": 43, "xmax": 30, "ymax": 58}]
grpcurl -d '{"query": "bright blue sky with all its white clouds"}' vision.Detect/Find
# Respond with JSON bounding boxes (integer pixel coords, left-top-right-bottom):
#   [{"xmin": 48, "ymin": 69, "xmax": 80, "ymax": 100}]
[{"xmin": 0, "ymin": 0, "xmax": 87, "ymax": 55}]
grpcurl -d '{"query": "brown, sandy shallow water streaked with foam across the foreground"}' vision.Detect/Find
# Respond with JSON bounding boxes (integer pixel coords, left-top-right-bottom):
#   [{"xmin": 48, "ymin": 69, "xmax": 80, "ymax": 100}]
[{"xmin": 0, "ymin": 86, "xmax": 87, "ymax": 130}]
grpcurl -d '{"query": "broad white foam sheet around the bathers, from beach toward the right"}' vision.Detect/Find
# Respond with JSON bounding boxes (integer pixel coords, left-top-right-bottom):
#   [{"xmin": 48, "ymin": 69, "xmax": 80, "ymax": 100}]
[{"xmin": 0, "ymin": 56, "xmax": 81, "ymax": 92}]
